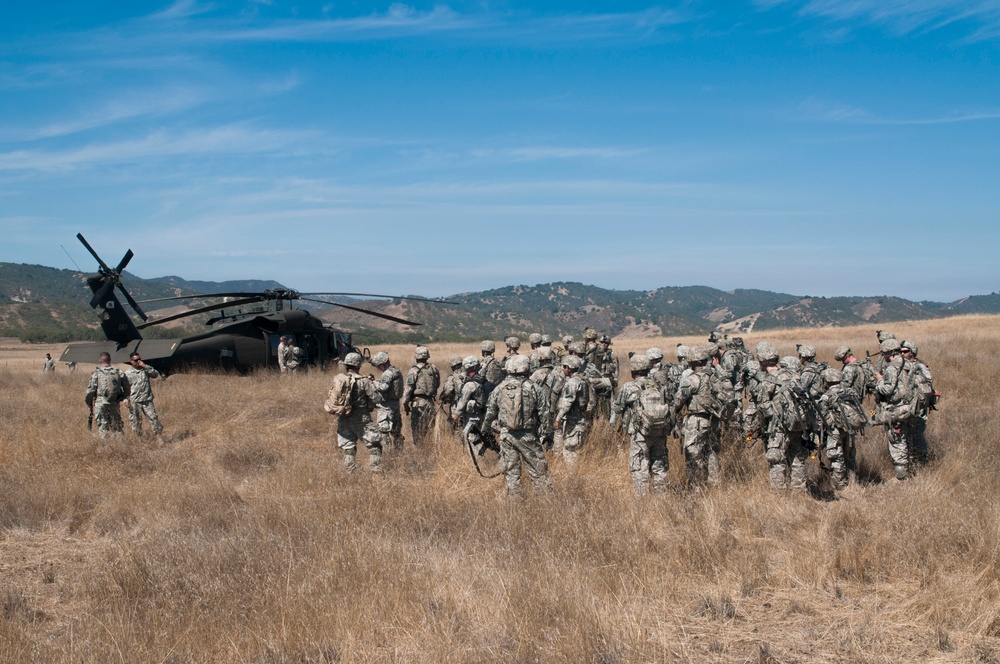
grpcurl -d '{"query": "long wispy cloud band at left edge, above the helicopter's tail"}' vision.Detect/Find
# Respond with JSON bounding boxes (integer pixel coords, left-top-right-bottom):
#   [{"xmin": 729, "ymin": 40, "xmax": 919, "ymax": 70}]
[{"xmin": 0, "ymin": 125, "xmax": 316, "ymax": 171}]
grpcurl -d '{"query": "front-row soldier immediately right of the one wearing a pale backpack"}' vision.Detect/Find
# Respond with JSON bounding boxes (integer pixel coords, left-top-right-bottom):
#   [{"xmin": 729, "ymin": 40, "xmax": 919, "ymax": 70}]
[{"xmin": 673, "ymin": 344, "xmax": 722, "ymax": 487}]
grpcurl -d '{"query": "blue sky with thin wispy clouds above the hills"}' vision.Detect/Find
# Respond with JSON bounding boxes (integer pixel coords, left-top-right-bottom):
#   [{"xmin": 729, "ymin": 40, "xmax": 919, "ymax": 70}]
[{"xmin": 0, "ymin": 0, "xmax": 1000, "ymax": 301}]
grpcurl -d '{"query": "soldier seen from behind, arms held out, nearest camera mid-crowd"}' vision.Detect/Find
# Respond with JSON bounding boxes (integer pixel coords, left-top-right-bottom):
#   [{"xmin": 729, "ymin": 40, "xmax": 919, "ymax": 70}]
[{"xmin": 483, "ymin": 355, "xmax": 552, "ymax": 496}]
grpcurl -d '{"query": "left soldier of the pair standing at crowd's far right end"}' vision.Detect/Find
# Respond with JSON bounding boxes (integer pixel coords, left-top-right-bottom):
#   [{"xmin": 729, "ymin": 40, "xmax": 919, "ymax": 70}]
[{"xmin": 875, "ymin": 339, "xmax": 914, "ymax": 480}]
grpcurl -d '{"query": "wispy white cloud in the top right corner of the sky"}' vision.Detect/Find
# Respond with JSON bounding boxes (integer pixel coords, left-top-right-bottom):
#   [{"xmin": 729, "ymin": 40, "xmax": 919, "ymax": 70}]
[{"xmin": 756, "ymin": 0, "xmax": 1000, "ymax": 41}]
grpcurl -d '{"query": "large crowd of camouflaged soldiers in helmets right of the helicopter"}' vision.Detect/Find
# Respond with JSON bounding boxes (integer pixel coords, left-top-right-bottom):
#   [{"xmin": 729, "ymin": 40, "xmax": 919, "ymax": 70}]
[{"xmin": 328, "ymin": 328, "xmax": 937, "ymax": 495}]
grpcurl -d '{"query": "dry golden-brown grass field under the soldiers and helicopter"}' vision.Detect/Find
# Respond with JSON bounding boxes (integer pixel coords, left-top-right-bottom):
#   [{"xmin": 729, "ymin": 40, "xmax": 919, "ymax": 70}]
[{"xmin": 0, "ymin": 317, "xmax": 1000, "ymax": 663}]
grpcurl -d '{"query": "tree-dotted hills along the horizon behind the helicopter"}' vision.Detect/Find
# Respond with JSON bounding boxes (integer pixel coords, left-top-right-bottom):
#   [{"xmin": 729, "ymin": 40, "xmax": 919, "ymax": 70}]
[{"xmin": 0, "ymin": 263, "xmax": 1000, "ymax": 343}]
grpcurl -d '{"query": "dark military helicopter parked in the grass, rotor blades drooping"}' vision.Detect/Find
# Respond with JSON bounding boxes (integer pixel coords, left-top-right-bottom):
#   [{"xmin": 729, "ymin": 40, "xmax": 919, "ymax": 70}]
[{"xmin": 59, "ymin": 233, "xmax": 442, "ymax": 373}]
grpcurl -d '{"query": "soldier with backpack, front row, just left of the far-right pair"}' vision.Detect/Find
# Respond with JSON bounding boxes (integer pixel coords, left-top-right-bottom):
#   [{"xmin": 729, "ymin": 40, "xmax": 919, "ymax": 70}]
[{"xmin": 818, "ymin": 369, "xmax": 868, "ymax": 489}]
